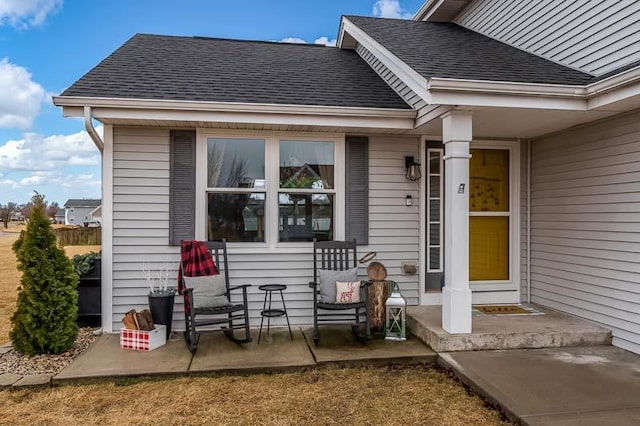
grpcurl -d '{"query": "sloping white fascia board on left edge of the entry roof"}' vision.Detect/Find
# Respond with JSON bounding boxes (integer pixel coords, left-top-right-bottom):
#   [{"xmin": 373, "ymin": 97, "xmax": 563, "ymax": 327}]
[{"xmin": 342, "ymin": 18, "xmax": 429, "ymax": 100}]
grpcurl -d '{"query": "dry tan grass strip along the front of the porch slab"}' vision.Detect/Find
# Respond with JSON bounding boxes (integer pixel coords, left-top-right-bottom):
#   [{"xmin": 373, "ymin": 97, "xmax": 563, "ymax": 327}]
[{"xmin": 0, "ymin": 367, "xmax": 506, "ymax": 425}]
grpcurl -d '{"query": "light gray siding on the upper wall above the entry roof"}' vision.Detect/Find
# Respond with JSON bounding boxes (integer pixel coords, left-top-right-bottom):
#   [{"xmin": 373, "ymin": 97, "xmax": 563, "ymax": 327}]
[{"xmin": 456, "ymin": 0, "xmax": 640, "ymax": 75}]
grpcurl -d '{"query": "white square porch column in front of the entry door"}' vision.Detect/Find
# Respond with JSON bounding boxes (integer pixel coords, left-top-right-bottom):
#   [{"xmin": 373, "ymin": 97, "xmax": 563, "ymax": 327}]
[{"xmin": 442, "ymin": 111, "xmax": 473, "ymax": 333}]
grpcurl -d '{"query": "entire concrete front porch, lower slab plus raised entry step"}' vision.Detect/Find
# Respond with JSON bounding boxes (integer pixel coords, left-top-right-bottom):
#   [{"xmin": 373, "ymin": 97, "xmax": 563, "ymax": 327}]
[{"xmin": 46, "ymin": 306, "xmax": 611, "ymax": 383}]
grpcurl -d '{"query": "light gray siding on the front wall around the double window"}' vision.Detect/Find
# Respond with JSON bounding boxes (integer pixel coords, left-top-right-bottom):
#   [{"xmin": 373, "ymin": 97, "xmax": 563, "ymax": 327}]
[{"xmin": 112, "ymin": 127, "xmax": 420, "ymax": 330}]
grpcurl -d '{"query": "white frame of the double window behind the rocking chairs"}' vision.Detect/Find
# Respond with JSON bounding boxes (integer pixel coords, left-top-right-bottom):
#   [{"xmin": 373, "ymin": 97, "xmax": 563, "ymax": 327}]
[{"xmin": 195, "ymin": 129, "xmax": 346, "ymax": 253}]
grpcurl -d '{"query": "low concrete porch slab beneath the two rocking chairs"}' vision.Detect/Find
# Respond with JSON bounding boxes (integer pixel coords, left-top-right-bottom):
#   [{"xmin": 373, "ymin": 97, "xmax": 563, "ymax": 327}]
[{"xmin": 53, "ymin": 327, "xmax": 436, "ymax": 383}]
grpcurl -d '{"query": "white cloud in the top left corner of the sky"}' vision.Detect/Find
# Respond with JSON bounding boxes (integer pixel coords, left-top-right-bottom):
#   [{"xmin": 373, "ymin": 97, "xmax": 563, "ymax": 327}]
[{"xmin": 0, "ymin": 0, "xmax": 62, "ymax": 28}]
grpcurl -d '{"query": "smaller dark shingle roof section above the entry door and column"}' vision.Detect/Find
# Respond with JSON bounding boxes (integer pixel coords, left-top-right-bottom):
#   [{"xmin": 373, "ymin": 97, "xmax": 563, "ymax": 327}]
[{"xmin": 345, "ymin": 16, "xmax": 593, "ymax": 84}]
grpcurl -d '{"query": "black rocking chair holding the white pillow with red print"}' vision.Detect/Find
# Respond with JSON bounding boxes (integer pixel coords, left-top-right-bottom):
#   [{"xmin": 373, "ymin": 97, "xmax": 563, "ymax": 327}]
[{"xmin": 309, "ymin": 239, "xmax": 371, "ymax": 345}]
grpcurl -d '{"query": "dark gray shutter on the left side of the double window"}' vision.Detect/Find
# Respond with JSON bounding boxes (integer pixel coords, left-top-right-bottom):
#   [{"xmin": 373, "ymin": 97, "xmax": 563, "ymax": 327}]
[{"xmin": 169, "ymin": 130, "xmax": 196, "ymax": 246}]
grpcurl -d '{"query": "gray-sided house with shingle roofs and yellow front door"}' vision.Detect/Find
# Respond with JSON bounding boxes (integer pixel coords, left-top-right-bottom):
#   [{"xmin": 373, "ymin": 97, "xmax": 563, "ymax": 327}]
[{"xmin": 54, "ymin": 0, "xmax": 640, "ymax": 353}]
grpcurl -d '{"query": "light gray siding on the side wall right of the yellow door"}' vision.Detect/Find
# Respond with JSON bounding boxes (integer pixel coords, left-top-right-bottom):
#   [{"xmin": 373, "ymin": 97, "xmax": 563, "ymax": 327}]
[{"xmin": 531, "ymin": 108, "xmax": 640, "ymax": 353}]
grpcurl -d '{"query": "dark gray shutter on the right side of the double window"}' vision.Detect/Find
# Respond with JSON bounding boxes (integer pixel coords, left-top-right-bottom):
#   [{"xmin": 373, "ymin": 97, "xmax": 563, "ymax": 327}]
[{"xmin": 345, "ymin": 136, "xmax": 369, "ymax": 245}]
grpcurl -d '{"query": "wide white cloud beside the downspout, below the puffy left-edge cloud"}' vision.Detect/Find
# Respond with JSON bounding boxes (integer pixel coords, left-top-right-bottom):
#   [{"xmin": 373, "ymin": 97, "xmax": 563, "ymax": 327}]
[{"xmin": 0, "ymin": 126, "xmax": 103, "ymax": 175}]
